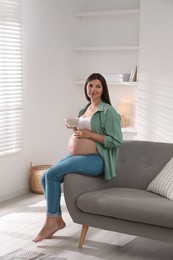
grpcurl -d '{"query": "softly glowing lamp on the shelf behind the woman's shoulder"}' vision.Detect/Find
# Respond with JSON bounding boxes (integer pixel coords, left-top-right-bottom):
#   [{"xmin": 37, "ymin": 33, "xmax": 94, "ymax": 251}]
[{"xmin": 116, "ymin": 101, "xmax": 130, "ymax": 128}]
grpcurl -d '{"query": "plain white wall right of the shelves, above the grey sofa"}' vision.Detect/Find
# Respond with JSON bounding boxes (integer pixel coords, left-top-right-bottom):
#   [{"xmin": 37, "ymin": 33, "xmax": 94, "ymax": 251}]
[{"xmin": 137, "ymin": 0, "xmax": 173, "ymax": 143}]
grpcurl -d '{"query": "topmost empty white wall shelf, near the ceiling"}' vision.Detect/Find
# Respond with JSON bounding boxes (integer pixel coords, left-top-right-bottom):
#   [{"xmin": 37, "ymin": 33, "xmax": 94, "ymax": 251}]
[{"xmin": 73, "ymin": 9, "xmax": 140, "ymax": 18}]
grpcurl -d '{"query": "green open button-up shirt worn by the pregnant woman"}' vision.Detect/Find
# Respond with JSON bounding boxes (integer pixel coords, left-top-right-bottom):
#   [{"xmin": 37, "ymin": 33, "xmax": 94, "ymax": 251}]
[{"xmin": 79, "ymin": 101, "xmax": 122, "ymax": 180}]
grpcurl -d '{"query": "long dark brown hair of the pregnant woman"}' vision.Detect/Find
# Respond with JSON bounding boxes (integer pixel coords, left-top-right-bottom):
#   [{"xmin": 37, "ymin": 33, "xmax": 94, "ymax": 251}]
[{"xmin": 84, "ymin": 73, "xmax": 111, "ymax": 105}]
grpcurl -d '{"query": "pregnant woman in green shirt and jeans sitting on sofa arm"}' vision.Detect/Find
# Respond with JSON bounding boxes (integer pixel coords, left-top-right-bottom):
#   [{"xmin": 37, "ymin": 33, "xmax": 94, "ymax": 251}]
[{"xmin": 33, "ymin": 73, "xmax": 122, "ymax": 243}]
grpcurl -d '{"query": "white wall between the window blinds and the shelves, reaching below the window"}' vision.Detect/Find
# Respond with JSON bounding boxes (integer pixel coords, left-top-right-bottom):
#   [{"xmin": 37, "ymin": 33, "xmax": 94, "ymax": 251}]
[{"xmin": 0, "ymin": 0, "xmax": 79, "ymax": 201}]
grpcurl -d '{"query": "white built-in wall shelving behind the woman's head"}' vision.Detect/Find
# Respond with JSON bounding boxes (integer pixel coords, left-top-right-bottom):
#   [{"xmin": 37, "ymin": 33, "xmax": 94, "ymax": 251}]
[{"xmin": 74, "ymin": 6, "xmax": 140, "ymax": 138}]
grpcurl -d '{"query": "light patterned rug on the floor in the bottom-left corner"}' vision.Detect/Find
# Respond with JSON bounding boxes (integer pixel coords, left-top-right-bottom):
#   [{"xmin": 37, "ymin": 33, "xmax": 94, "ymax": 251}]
[{"xmin": 0, "ymin": 248, "xmax": 66, "ymax": 260}]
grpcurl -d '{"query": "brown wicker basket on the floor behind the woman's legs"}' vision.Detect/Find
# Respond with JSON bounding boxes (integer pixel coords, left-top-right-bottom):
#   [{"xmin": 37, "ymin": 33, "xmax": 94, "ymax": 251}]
[{"xmin": 30, "ymin": 163, "xmax": 52, "ymax": 194}]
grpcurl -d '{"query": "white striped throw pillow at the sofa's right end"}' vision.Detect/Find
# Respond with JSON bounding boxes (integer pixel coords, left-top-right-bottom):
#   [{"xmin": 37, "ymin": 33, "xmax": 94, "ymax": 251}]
[{"xmin": 147, "ymin": 158, "xmax": 173, "ymax": 200}]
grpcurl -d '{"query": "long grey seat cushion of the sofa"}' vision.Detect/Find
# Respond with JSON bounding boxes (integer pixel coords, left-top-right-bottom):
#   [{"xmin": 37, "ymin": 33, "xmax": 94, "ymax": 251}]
[{"xmin": 76, "ymin": 188, "xmax": 173, "ymax": 228}]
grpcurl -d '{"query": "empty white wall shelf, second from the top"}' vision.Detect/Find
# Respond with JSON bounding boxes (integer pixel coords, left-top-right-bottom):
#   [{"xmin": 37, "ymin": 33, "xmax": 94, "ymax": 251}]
[{"xmin": 74, "ymin": 45, "xmax": 139, "ymax": 51}]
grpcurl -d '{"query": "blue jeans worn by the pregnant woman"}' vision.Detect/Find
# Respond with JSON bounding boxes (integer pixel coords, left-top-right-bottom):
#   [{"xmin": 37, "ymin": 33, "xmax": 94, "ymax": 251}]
[{"xmin": 41, "ymin": 154, "xmax": 104, "ymax": 217}]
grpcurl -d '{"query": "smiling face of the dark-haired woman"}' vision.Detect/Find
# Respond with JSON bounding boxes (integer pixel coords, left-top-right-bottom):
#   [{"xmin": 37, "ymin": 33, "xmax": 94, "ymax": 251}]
[{"xmin": 86, "ymin": 79, "xmax": 103, "ymax": 101}]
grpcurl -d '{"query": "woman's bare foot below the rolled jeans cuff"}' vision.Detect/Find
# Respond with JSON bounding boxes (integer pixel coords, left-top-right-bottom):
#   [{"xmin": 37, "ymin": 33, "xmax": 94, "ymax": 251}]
[{"xmin": 33, "ymin": 216, "xmax": 65, "ymax": 243}]
